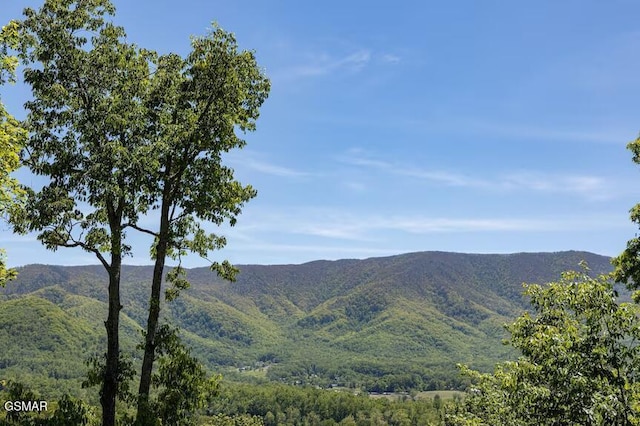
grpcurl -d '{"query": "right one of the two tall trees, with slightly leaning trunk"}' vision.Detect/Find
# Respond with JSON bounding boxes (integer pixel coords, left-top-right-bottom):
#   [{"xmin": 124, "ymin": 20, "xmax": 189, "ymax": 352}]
[{"xmin": 132, "ymin": 26, "xmax": 269, "ymax": 424}]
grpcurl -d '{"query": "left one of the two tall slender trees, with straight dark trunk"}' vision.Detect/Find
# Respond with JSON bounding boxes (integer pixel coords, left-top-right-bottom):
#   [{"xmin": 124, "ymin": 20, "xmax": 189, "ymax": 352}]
[{"xmin": 4, "ymin": 0, "xmax": 153, "ymax": 426}]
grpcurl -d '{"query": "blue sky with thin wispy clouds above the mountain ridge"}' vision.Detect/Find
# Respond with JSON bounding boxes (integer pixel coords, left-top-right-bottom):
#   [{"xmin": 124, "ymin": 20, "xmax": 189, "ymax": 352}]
[{"xmin": 0, "ymin": 0, "xmax": 640, "ymax": 267}]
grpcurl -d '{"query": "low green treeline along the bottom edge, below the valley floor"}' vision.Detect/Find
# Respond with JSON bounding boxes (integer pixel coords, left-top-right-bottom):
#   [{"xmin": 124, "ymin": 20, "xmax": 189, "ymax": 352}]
[{"xmin": 0, "ymin": 382, "xmax": 462, "ymax": 426}]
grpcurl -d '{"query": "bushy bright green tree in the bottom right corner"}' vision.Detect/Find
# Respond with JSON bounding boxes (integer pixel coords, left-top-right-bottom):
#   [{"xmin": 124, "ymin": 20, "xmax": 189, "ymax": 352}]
[{"xmin": 446, "ymin": 269, "xmax": 640, "ymax": 426}]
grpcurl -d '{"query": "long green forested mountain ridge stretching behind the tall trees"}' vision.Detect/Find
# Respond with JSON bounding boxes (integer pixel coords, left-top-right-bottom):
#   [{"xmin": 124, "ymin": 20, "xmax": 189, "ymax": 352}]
[{"xmin": 0, "ymin": 251, "xmax": 611, "ymax": 393}]
